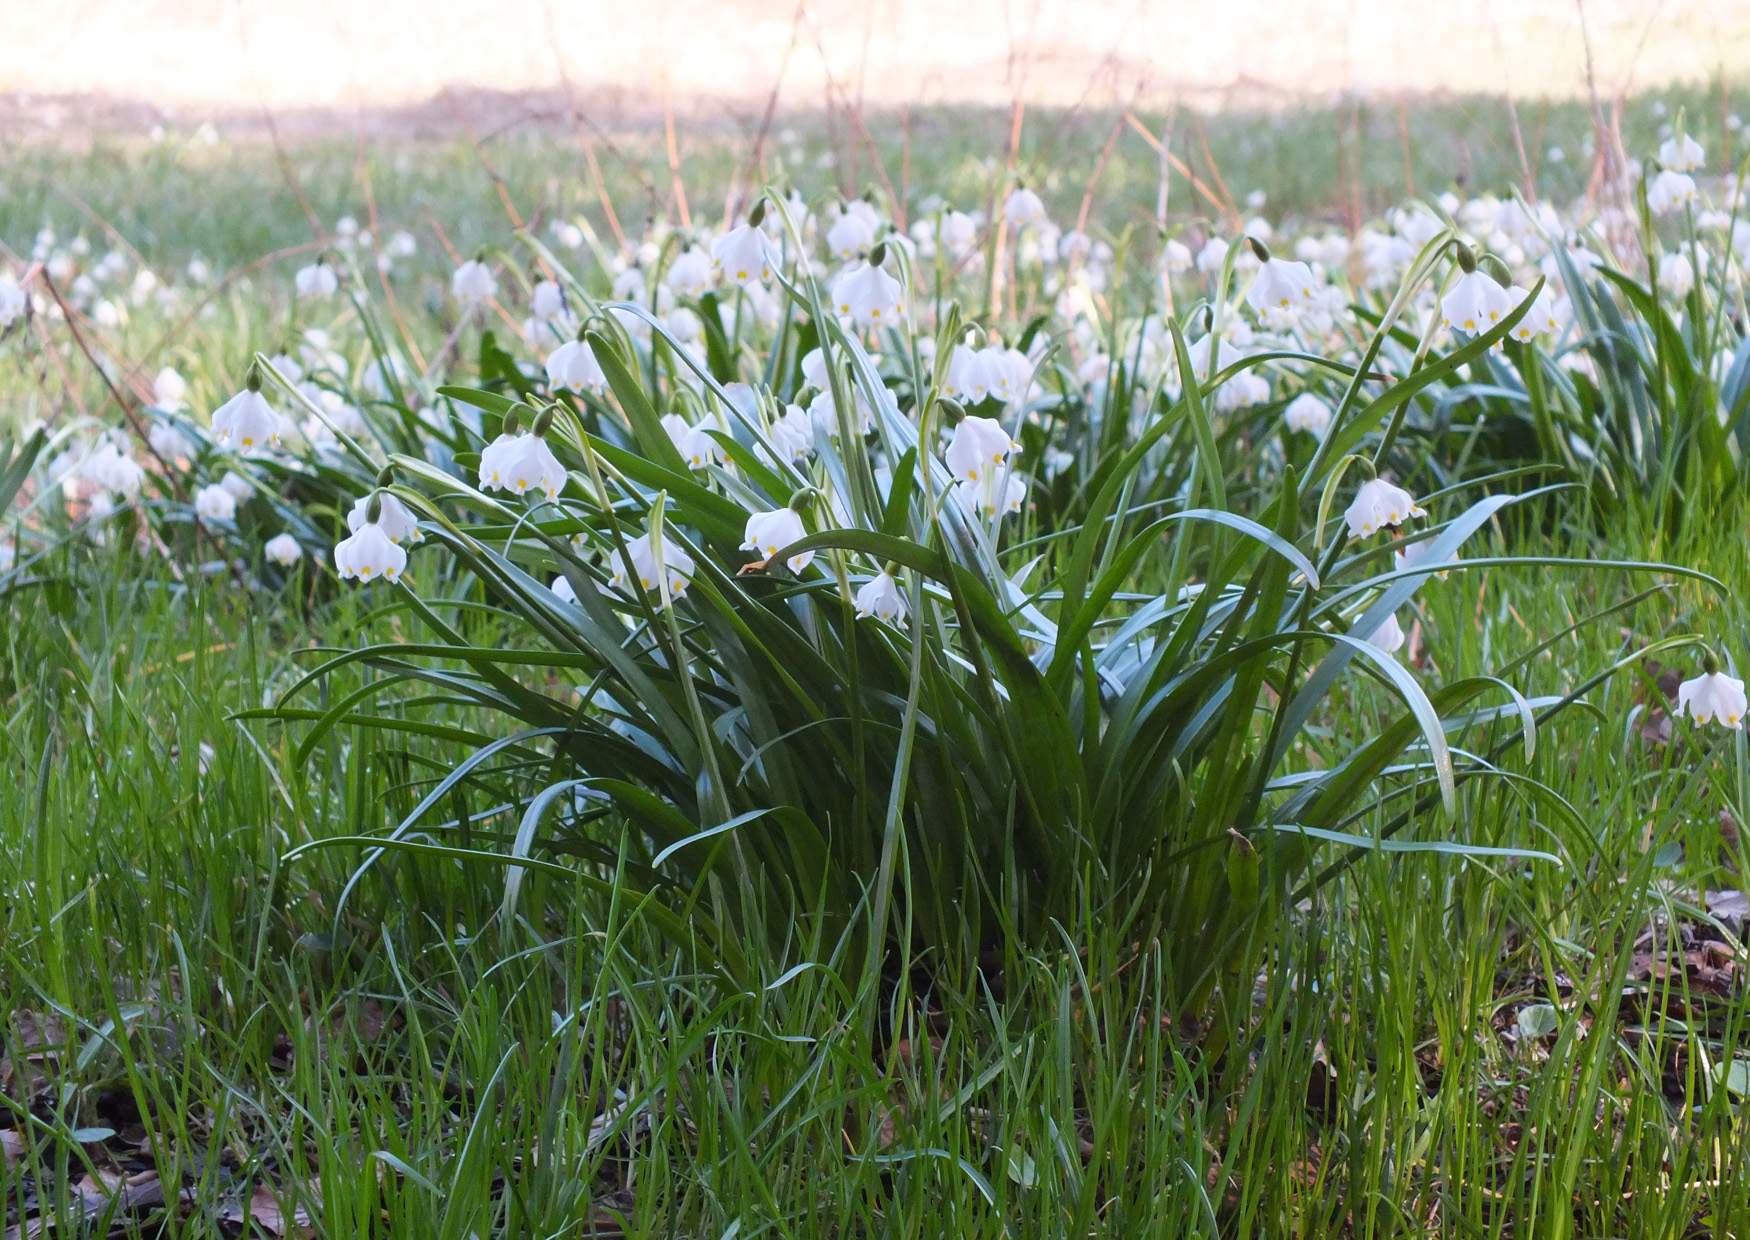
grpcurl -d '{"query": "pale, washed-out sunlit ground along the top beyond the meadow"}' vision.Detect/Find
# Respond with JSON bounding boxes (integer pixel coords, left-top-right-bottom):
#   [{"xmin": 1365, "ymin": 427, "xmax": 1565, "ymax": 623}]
[{"xmin": 0, "ymin": 0, "xmax": 1750, "ymax": 131}]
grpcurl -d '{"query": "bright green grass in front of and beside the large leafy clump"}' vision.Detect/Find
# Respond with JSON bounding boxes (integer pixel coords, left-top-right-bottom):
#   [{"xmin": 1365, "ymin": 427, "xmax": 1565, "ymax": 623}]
[{"xmin": 0, "ymin": 505, "xmax": 1750, "ymax": 1237}]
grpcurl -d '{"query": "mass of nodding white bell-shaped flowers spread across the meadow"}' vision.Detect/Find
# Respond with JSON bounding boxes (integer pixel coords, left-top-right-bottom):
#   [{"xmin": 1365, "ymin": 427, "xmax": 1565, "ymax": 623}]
[{"xmin": 0, "ymin": 110, "xmax": 1750, "ymax": 703}]
